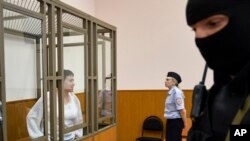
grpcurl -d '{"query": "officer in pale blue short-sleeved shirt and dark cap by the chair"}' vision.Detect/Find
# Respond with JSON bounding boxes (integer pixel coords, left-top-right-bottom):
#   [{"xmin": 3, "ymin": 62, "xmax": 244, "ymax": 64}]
[{"xmin": 164, "ymin": 72, "xmax": 186, "ymax": 141}]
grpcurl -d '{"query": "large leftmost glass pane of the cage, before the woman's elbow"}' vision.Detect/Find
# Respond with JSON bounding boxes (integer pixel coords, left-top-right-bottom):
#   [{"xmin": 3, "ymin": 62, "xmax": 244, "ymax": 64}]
[{"xmin": 3, "ymin": 9, "xmax": 44, "ymax": 140}]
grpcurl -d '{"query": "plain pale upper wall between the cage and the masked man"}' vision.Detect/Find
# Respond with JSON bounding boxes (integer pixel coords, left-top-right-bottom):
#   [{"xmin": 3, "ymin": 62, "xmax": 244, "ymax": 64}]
[{"xmin": 95, "ymin": 0, "xmax": 212, "ymax": 89}]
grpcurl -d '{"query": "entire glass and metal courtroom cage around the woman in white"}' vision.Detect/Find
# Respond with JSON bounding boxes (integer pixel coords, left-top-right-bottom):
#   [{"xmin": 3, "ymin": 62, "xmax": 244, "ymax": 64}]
[{"xmin": 0, "ymin": 0, "xmax": 117, "ymax": 141}]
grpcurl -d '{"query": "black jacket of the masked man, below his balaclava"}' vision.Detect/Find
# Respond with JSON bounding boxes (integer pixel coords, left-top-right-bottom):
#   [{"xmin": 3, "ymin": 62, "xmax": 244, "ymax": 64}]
[{"xmin": 188, "ymin": 63, "xmax": 250, "ymax": 141}]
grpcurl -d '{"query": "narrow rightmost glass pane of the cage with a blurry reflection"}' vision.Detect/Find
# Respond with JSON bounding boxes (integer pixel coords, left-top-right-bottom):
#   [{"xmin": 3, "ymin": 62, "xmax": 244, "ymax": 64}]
[{"xmin": 97, "ymin": 38, "xmax": 114, "ymax": 129}]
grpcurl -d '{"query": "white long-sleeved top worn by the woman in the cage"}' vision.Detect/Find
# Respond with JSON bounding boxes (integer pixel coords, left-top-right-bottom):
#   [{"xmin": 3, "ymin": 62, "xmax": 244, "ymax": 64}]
[{"xmin": 26, "ymin": 93, "xmax": 83, "ymax": 140}]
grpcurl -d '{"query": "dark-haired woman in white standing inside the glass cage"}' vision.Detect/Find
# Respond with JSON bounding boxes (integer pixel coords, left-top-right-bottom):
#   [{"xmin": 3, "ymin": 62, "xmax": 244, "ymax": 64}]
[{"xmin": 26, "ymin": 70, "xmax": 83, "ymax": 141}]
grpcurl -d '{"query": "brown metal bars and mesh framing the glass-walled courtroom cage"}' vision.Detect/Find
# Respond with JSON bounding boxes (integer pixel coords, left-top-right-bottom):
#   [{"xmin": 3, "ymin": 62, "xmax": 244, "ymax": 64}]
[{"xmin": 0, "ymin": 0, "xmax": 117, "ymax": 141}]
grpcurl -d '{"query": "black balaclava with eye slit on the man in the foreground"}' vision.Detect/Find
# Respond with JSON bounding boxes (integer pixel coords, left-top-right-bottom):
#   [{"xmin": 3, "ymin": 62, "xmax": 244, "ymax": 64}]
[{"xmin": 186, "ymin": 0, "xmax": 250, "ymax": 75}]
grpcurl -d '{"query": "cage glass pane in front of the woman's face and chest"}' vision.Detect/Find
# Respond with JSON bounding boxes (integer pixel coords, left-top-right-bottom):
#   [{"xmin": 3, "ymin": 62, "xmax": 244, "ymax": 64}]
[{"xmin": 63, "ymin": 28, "xmax": 87, "ymax": 137}]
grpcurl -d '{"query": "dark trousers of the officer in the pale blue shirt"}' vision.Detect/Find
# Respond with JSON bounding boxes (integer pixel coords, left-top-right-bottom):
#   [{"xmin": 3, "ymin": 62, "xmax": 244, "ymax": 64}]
[{"xmin": 166, "ymin": 118, "xmax": 184, "ymax": 141}]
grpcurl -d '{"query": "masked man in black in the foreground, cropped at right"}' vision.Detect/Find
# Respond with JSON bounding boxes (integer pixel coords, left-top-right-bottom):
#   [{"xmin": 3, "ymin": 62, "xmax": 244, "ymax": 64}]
[{"xmin": 186, "ymin": 0, "xmax": 250, "ymax": 141}]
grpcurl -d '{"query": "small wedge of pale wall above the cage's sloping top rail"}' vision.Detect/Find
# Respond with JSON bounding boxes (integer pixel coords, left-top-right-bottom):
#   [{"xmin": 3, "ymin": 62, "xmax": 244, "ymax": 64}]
[{"xmin": 60, "ymin": 0, "xmax": 95, "ymax": 16}]
